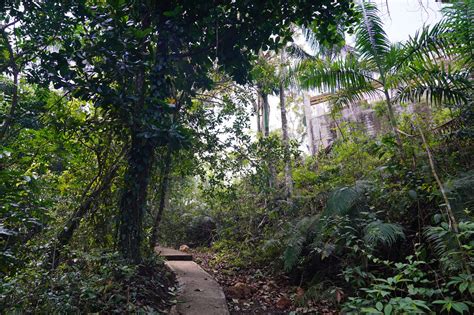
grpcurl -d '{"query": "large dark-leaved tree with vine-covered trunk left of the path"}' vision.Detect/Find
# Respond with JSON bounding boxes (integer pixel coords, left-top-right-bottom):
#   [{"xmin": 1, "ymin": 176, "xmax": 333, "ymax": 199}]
[{"xmin": 31, "ymin": 0, "xmax": 358, "ymax": 262}]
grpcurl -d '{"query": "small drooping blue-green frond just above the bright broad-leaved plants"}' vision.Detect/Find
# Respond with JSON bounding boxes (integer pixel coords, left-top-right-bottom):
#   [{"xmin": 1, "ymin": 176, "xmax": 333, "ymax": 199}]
[{"xmin": 364, "ymin": 220, "xmax": 405, "ymax": 247}]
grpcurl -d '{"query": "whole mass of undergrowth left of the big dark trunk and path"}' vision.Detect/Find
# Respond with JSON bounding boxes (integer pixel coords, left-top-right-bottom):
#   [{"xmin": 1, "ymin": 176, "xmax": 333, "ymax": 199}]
[{"xmin": 0, "ymin": 79, "xmax": 180, "ymax": 313}]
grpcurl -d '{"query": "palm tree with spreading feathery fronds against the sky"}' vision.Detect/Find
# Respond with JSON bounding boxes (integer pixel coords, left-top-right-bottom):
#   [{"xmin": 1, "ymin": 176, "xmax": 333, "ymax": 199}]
[{"xmin": 298, "ymin": 1, "xmax": 471, "ymax": 153}]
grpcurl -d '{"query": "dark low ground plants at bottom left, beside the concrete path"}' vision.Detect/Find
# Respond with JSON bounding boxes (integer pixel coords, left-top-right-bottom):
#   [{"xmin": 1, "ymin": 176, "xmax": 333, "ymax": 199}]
[{"xmin": 0, "ymin": 251, "xmax": 174, "ymax": 313}]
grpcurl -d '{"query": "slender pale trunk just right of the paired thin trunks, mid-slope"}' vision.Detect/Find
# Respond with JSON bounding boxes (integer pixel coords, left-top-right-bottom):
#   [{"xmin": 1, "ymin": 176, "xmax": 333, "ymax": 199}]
[{"xmin": 280, "ymin": 51, "xmax": 293, "ymax": 200}]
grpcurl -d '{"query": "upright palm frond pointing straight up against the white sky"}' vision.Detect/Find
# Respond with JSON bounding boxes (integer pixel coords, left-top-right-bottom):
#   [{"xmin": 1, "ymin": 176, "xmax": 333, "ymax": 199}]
[{"xmin": 355, "ymin": 1, "xmax": 390, "ymax": 66}]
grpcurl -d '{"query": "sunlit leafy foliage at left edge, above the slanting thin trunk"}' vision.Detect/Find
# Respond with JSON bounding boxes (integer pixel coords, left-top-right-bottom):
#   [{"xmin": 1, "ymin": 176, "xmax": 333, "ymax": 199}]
[{"xmin": 0, "ymin": 84, "xmax": 97, "ymax": 274}]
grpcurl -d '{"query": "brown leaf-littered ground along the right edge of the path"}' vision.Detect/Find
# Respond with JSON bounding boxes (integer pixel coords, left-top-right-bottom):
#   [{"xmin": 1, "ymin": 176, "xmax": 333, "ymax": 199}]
[{"xmin": 192, "ymin": 250, "xmax": 338, "ymax": 315}]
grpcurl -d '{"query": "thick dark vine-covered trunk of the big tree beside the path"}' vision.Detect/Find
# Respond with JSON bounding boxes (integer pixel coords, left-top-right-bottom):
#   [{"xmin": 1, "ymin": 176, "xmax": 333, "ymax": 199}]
[{"xmin": 118, "ymin": 132, "xmax": 154, "ymax": 263}]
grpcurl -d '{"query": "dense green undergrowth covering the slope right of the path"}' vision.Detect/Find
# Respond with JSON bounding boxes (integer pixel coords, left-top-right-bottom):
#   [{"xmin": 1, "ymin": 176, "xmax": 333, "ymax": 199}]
[{"xmin": 160, "ymin": 113, "xmax": 474, "ymax": 314}]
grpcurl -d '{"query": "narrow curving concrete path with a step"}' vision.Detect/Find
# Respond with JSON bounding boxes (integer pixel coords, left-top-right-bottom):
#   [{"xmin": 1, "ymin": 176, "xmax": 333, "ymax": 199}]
[{"xmin": 156, "ymin": 247, "xmax": 229, "ymax": 315}]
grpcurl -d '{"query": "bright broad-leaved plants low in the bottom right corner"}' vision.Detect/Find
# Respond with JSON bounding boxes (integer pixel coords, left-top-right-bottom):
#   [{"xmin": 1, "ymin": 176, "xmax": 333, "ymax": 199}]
[{"xmin": 343, "ymin": 256, "xmax": 474, "ymax": 314}]
